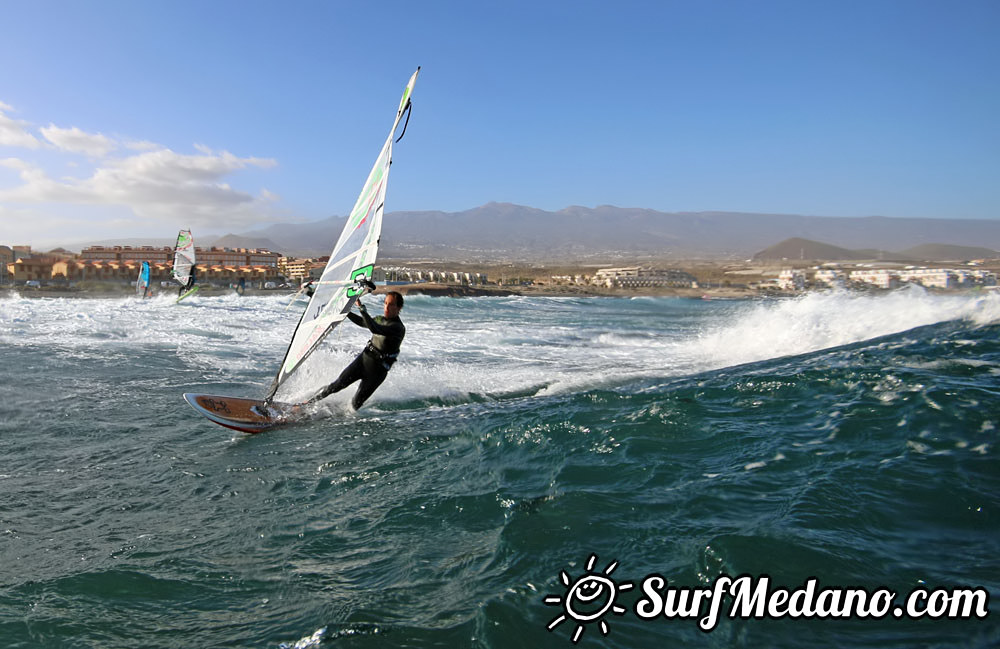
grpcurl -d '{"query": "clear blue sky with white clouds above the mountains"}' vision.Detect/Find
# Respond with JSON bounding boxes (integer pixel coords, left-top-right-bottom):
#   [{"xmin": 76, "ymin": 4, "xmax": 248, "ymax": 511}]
[{"xmin": 0, "ymin": 0, "xmax": 1000, "ymax": 247}]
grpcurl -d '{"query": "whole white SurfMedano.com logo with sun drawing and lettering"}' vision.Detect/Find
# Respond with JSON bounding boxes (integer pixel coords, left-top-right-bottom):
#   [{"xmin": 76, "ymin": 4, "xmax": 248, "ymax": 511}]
[{"xmin": 543, "ymin": 554, "xmax": 990, "ymax": 644}]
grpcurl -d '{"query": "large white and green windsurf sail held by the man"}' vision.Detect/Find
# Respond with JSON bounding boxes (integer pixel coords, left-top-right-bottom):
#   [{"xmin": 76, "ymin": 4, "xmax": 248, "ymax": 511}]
[{"xmin": 267, "ymin": 67, "xmax": 420, "ymax": 400}]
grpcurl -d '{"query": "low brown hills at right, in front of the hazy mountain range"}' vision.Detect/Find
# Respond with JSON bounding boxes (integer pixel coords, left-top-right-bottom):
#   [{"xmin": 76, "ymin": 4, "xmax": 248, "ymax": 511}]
[{"xmin": 753, "ymin": 237, "xmax": 1000, "ymax": 262}]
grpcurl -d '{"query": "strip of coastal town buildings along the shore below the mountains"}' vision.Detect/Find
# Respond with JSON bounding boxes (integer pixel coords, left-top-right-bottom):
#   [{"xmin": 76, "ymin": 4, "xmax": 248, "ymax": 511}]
[{"xmin": 0, "ymin": 245, "xmax": 1000, "ymax": 299}]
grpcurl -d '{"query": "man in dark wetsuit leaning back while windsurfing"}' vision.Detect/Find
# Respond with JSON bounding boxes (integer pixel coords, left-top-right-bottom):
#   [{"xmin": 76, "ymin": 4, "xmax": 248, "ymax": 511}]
[{"xmin": 306, "ymin": 291, "xmax": 406, "ymax": 410}]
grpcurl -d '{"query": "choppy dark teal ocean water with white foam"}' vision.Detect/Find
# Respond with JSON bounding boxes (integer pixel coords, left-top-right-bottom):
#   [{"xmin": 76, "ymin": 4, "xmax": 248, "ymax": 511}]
[{"xmin": 0, "ymin": 289, "xmax": 1000, "ymax": 649}]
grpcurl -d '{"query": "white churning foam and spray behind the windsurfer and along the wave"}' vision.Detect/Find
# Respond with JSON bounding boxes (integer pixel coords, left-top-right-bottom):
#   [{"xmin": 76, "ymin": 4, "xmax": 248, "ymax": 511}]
[{"xmin": 0, "ymin": 289, "xmax": 1000, "ymax": 405}]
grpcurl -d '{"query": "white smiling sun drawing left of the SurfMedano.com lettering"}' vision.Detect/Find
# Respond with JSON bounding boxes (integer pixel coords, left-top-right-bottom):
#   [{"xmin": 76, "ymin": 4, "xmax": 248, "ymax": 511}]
[{"xmin": 544, "ymin": 554, "xmax": 632, "ymax": 644}]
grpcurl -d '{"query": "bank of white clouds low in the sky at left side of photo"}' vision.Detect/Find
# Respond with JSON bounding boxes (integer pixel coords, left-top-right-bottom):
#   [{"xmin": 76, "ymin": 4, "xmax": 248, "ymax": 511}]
[{"xmin": 0, "ymin": 102, "xmax": 280, "ymax": 243}]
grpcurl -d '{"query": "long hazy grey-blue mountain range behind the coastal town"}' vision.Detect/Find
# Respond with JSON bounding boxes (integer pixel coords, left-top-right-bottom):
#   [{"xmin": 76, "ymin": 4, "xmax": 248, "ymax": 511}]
[{"xmin": 66, "ymin": 203, "xmax": 1000, "ymax": 263}]
